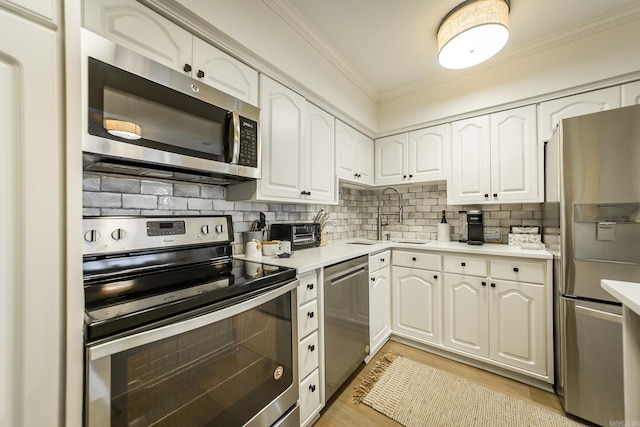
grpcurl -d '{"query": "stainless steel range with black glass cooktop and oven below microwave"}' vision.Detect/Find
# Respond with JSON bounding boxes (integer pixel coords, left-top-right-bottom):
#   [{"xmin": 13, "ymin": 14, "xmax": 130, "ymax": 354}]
[{"xmin": 84, "ymin": 216, "xmax": 299, "ymax": 426}]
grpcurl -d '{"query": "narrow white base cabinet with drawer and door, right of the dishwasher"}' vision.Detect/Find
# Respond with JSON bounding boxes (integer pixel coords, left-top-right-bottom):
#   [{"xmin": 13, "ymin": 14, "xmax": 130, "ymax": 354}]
[{"xmin": 368, "ymin": 251, "xmax": 391, "ymax": 359}]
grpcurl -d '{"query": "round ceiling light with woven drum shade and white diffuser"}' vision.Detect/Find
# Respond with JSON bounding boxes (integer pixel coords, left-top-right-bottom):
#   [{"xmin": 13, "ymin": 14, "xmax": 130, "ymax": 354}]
[{"xmin": 437, "ymin": 0, "xmax": 510, "ymax": 69}]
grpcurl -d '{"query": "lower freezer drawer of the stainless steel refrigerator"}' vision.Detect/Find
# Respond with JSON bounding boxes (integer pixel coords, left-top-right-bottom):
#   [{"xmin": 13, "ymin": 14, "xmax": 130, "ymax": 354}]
[{"xmin": 557, "ymin": 298, "xmax": 624, "ymax": 426}]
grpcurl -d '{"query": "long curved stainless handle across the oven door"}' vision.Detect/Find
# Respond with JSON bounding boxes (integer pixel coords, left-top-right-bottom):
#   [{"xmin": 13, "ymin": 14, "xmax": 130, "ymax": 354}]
[{"xmin": 87, "ymin": 279, "xmax": 300, "ymax": 362}]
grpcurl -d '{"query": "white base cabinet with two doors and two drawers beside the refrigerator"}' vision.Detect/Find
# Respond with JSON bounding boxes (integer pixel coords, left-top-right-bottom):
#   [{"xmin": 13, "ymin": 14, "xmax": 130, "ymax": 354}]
[{"xmin": 443, "ymin": 255, "xmax": 553, "ymax": 376}]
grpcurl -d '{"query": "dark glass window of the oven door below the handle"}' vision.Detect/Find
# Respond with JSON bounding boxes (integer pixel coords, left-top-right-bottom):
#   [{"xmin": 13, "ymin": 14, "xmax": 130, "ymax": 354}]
[{"xmin": 98, "ymin": 293, "xmax": 294, "ymax": 426}]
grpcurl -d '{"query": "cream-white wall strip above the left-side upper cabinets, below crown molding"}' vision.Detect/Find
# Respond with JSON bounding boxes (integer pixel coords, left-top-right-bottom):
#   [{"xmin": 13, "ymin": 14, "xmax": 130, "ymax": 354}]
[{"xmin": 178, "ymin": 0, "xmax": 378, "ymax": 135}]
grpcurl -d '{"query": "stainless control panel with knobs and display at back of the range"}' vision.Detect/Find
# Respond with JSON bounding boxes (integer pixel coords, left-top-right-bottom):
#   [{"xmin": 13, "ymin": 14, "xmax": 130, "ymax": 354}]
[{"xmin": 82, "ymin": 215, "xmax": 233, "ymax": 255}]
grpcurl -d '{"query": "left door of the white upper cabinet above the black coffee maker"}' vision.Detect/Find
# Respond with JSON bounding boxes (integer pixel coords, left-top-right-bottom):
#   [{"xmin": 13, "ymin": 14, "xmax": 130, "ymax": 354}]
[{"xmin": 447, "ymin": 116, "xmax": 491, "ymax": 204}]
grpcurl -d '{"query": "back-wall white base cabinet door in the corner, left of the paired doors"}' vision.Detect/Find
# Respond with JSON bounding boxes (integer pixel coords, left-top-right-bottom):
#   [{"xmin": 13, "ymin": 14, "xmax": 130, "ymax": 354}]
[{"xmin": 392, "ymin": 266, "xmax": 441, "ymax": 343}]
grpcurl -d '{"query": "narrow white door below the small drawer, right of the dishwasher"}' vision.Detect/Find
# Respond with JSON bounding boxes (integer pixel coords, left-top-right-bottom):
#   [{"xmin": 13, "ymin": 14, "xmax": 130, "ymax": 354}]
[{"xmin": 369, "ymin": 267, "xmax": 391, "ymax": 354}]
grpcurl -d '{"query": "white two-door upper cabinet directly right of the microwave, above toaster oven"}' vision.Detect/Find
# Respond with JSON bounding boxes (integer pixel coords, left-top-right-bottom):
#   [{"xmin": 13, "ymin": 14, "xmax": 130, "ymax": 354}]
[{"xmin": 227, "ymin": 75, "xmax": 338, "ymax": 204}]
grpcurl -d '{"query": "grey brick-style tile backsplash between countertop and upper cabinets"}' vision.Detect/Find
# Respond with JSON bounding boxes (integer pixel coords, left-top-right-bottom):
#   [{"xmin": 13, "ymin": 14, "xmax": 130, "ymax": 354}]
[{"xmin": 83, "ymin": 172, "xmax": 542, "ymax": 253}]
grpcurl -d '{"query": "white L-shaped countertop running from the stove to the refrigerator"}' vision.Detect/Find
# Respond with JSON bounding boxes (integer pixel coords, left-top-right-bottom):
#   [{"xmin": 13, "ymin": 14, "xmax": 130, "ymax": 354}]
[{"xmin": 235, "ymin": 238, "xmax": 553, "ymax": 274}]
